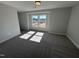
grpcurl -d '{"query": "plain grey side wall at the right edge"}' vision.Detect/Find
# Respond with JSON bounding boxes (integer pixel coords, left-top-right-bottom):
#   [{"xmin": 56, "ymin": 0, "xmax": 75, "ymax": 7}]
[{"xmin": 67, "ymin": 4, "xmax": 79, "ymax": 48}]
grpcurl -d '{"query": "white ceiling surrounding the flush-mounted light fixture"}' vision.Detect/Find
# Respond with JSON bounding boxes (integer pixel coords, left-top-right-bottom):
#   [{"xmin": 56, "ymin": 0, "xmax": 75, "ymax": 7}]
[{"xmin": 0, "ymin": 1, "xmax": 79, "ymax": 11}]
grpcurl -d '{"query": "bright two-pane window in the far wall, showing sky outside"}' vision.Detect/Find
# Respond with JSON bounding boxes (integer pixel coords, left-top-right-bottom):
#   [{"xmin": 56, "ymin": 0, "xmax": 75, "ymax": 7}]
[{"xmin": 32, "ymin": 14, "xmax": 47, "ymax": 28}]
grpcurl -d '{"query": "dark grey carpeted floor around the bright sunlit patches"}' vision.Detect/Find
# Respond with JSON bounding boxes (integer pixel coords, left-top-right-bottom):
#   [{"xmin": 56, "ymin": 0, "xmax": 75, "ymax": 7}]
[{"xmin": 0, "ymin": 33, "xmax": 79, "ymax": 58}]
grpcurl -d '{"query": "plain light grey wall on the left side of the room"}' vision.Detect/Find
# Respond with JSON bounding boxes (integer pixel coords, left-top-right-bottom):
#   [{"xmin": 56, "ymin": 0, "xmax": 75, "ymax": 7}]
[{"xmin": 0, "ymin": 3, "xmax": 20, "ymax": 43}]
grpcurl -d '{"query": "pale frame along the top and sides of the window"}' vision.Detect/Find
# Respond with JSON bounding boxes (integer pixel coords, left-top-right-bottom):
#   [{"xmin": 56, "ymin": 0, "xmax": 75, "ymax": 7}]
[{"xmin": 26, "ymin": 11, "xmax": 50, "ymax": 31}]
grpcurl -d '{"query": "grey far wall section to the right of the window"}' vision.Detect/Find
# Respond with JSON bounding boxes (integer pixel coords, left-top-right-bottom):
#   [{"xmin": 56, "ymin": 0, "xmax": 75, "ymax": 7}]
[{"xmin": 49, "ymin": 8, "xmax": 72, "ymax": 34}]
